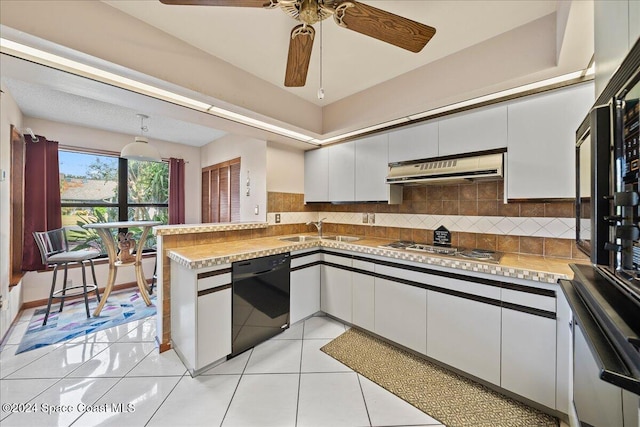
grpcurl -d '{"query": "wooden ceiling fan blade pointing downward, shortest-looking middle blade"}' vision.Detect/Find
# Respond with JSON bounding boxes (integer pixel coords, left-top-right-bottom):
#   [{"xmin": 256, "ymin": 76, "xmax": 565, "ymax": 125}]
[{"xmin": 284, "ymin": 24, "xmax": 315, "ymax": 87}]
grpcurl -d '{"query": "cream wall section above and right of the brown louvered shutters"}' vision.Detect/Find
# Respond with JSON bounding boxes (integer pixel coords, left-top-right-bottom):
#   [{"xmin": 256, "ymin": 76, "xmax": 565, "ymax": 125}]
[{"xmin": 200, "ymin": 135, "xmax": 267, "ymax": 222}]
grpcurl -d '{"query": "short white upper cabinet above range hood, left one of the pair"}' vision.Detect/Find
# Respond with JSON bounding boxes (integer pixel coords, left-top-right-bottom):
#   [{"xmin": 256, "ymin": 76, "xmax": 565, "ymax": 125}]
[{"xmin": 389, "ymin": 122, "xmax": 438, "ymax": 163}]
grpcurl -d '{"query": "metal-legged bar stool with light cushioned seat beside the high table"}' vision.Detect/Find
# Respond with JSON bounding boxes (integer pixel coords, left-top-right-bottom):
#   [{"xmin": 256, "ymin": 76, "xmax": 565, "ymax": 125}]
[{"xmin": 33, "ymin": 227, "xmax": 100, "ymax": 326}]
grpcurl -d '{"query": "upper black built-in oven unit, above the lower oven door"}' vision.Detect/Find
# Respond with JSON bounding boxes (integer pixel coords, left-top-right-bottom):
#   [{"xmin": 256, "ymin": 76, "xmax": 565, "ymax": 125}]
[{"xmin": 576, "ymin": 40, "xmax": 640, "ymax": 309}]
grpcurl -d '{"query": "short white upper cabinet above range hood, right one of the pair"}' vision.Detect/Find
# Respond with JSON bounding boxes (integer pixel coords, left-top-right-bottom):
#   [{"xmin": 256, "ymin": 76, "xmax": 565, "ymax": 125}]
[{"xmin": 438, "ymin": 104, "xmax": 507, "ymax": 156}]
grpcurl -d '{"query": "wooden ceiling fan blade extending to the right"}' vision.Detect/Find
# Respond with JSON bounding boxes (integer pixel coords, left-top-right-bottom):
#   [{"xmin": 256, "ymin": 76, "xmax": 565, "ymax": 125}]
[{"xmin": 333, "ymin": 1, "xmax": 436, "ymax": 52}]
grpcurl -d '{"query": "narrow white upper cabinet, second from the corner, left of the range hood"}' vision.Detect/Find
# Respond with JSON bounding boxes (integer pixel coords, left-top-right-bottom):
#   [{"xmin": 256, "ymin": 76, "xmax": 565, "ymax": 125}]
[{"xmin": 327, "ymin": 141, "xmax": 356, "ymax": 202}]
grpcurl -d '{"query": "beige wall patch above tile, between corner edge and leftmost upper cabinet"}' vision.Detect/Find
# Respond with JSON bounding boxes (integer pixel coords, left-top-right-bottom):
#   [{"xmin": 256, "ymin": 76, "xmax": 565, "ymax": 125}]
[{"xmin": 267, "ymin": 142, "xmax": 304, "ymax": 193}]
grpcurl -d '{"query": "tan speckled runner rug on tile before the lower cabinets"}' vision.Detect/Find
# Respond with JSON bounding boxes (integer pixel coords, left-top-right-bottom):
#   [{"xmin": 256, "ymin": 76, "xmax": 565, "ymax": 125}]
[{"xmin": 321, "ymin": 328, "xmax": 558, "ymax": 427}]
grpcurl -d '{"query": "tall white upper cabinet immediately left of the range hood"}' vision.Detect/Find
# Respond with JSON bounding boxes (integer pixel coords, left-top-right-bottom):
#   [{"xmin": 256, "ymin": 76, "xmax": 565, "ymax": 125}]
[{"xmin": 355, "ymin": 134, "xmax": 389, "ymax": 202}]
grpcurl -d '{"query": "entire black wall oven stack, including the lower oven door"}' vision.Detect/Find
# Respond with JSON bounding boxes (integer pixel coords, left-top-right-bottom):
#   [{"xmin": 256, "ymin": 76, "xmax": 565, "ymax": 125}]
[{"xmin": 572, "ymin": 40, "xmax": 640, "ymax": 404}]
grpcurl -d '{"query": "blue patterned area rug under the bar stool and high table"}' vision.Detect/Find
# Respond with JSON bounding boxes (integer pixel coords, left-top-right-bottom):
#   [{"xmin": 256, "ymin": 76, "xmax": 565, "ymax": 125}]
[{"xmin": 16, "ymin": 290, "xmax": 156, "ymax": 354}]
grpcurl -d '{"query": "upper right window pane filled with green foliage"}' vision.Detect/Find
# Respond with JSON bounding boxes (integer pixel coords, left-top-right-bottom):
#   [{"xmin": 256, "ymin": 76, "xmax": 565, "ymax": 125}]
[{"xmin": 127, "ymin": 160, "xmax": 169, "ymax": 206}]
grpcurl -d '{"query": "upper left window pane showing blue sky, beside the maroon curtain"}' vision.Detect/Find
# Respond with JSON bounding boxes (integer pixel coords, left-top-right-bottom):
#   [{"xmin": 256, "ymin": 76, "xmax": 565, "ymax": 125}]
[{"xmin": 58, "ymin": 150, "xmax": 118, "ymax": 204}]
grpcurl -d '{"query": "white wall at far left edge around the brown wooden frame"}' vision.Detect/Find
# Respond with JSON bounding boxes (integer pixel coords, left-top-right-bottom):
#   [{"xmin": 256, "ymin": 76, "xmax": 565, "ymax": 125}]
[{"xmin": 0, "ymin": 85, "xmax": 22, "ymax": 339}]
